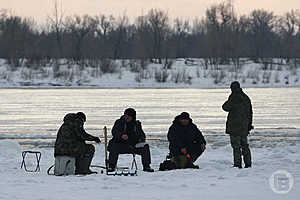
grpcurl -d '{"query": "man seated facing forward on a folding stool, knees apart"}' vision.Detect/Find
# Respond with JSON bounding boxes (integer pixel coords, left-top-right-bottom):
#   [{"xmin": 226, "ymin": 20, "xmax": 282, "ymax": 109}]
[{"xmin": 108, "ymin": 108, "xmax": 154, "ymax": 172}]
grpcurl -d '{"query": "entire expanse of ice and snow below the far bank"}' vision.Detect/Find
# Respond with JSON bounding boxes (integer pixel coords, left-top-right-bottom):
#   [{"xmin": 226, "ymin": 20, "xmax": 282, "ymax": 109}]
[{"xmin": 0, "ymin": 88, "xmax": 300, "ymax": 200}]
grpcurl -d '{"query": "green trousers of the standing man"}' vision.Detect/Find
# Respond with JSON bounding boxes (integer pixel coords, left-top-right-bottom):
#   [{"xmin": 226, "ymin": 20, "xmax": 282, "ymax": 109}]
[{"xmin": 230, "ymin": 135, "xmax": 251, "ymax": 166}]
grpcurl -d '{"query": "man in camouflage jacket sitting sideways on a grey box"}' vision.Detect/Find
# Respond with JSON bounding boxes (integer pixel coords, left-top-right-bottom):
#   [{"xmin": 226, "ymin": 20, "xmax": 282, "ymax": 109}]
[{"xmin": 54, "ymin": 112, "xmax": 100, "ymax": 174}]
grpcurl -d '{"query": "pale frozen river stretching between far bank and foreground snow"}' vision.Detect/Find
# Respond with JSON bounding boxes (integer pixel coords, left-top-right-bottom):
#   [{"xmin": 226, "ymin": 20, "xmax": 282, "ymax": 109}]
[{"xmin": 0, "ymin": 88, "xmax": 300, "ymax": 147}]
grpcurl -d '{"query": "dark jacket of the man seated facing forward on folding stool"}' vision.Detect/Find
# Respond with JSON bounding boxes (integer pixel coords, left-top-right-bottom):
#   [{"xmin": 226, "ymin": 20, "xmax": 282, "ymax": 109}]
[{"xmin": 110, "ymin": 116, "xmax": 146, "ymax": 146}]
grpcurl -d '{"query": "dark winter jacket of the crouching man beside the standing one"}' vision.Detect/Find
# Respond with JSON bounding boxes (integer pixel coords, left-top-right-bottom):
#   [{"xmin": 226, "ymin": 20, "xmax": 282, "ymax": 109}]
[{"xmin": 168, "ymin": 116, "xmax": 206, "ymax": 156}]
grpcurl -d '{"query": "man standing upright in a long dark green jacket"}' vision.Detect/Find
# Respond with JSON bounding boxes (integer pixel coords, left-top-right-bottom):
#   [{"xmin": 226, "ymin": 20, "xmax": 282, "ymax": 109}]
[{"xmin": 222, "ymin": 81, "xmax": 253, "ymax": 168}]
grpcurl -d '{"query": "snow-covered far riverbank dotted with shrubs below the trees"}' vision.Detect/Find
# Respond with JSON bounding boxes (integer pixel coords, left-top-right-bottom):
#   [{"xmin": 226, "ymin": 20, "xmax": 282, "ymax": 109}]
[{"xmin": 0, "ymin": 59, "xmax": 300, "ymax": 88}]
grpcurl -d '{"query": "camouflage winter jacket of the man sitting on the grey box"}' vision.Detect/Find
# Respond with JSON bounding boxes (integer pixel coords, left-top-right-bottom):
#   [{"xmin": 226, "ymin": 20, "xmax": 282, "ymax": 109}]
[{"xmin": 54, "ymin": 113, "xmax": 96, "ymax": 157}]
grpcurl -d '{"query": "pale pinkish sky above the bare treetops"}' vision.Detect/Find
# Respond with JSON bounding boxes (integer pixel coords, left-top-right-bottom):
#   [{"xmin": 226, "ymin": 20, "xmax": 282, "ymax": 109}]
[{"xmin": 0, "ymin": 0, "xmax": 300, "ymax": 21}]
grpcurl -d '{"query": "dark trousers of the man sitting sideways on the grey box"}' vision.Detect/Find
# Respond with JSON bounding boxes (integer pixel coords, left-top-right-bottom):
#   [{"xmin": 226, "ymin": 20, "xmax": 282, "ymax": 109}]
[{"xmin": 75, "ymin": 144, "xmax": 95, "ymax": 174}]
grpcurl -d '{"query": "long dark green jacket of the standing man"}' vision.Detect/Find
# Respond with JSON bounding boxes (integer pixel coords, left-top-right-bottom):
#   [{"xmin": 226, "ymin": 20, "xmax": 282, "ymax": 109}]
[{"xmin": 222, "ymin": 89, "xmax": 253, "ymax": 136}]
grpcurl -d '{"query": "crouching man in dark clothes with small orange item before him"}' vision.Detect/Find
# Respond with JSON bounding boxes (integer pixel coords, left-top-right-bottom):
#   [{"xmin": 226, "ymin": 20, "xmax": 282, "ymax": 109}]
[{"xmin": 168, "ymin": 112, "xmax": 206, "ymax": 168}]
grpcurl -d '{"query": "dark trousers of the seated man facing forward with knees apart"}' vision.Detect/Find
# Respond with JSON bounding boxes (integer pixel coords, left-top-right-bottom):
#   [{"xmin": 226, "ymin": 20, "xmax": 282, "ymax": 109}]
[{"xmin": 108, "ymin": 143, "xmax": 151, "ymax": 168}]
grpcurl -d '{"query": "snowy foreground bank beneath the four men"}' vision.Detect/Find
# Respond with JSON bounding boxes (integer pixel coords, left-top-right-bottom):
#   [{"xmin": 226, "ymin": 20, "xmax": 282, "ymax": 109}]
[{"xmin": 0, "ymin": 140, "xmax": 300, "ymax": 200}]
